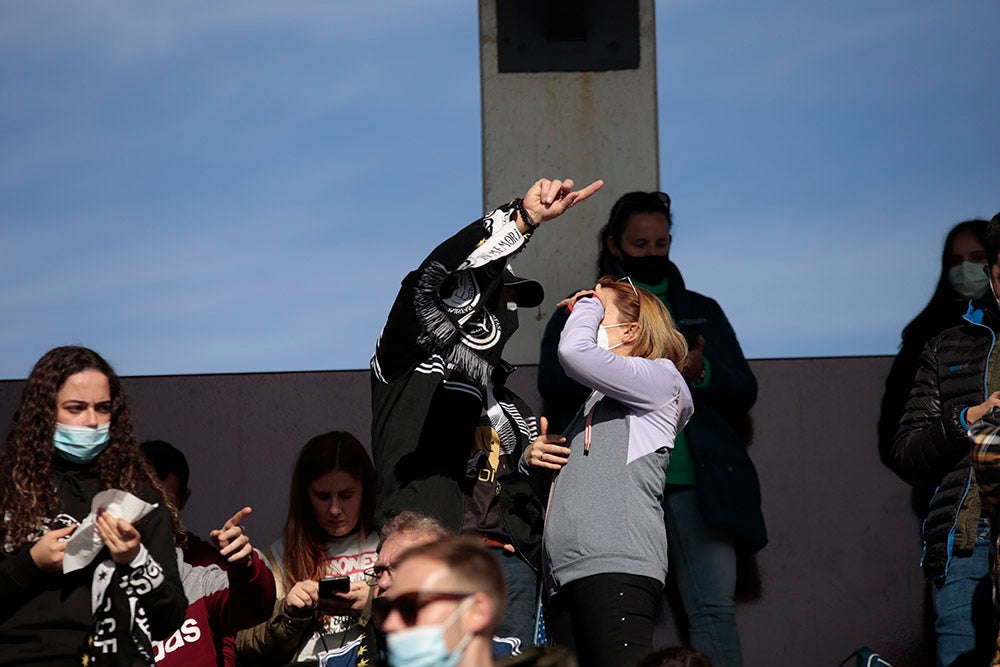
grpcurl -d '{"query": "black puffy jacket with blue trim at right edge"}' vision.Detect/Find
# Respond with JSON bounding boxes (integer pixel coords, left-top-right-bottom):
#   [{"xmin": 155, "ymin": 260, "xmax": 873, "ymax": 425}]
[{"xmin": 888, "ymin": 297, "xmax": 1000, "ymax": 578}]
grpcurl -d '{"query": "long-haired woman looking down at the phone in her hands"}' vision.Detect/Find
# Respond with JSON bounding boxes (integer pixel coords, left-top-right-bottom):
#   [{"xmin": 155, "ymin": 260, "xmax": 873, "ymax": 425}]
[{"xmin": 236, "ymin": 431, "xmax": 378, "ymax": 665}]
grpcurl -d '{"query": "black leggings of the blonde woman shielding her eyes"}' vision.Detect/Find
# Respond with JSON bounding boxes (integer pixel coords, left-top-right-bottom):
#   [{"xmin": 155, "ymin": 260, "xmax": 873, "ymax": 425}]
[{"xmin": 548, "ymin": 573, "xmax": 663, "ymax": 667}]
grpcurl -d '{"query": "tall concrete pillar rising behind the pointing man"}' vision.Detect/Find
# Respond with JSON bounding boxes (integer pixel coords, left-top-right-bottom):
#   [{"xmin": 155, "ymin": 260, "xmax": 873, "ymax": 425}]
[{"xmin": 479, "ymin": 0, "xmax": 660, "ymax": 364}]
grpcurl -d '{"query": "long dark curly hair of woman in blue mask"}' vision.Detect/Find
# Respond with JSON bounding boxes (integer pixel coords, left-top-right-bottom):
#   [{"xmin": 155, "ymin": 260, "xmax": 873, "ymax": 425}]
[{"xmin": 0, "ymin": 346, "xmax": 180, "ymax": 549}]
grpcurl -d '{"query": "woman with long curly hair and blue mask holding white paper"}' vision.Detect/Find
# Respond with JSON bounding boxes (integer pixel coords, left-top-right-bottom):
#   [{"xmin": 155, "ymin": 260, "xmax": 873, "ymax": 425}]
[{"xmin": 0, "ymin": 347, "xmax": 187, "ymax": 667}]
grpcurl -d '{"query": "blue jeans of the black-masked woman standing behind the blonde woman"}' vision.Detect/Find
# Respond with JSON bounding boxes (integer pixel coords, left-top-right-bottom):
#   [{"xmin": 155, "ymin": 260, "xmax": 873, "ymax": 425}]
[{"xmin": 663, "ymin": 487, "xmax": 743, "ymax": 667}]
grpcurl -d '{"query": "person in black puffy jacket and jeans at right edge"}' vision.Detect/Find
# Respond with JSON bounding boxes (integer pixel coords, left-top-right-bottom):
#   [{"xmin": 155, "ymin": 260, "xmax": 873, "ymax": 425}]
[{"xmin": 889, "ymin": 220, "xmax": 1000, "ymax": 665}]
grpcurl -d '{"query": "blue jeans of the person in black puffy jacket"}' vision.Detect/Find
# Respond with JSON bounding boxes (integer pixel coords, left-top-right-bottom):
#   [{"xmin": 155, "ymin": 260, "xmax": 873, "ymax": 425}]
[{"xmin": 934, "ymin": 521, "xmax": 996, "ymax": 666}]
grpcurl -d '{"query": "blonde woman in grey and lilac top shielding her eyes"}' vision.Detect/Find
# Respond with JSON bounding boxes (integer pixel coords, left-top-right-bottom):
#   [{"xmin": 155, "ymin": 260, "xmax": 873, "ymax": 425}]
[{"xmin": 521, "ymin": 277, "xmax": 693, "ymax": 667}]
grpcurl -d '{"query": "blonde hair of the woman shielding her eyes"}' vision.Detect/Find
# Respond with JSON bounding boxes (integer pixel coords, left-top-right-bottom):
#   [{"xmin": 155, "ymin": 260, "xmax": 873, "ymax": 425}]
[{"xmin": 598, "ymin": 276, "xmax": 688, "ymax": 369}]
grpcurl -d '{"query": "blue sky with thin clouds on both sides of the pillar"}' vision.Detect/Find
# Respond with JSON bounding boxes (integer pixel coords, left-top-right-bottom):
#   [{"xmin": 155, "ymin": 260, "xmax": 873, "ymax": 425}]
[{"xmin": 0, "ymin": 0, "xmax": 1000, "ymax": 378}]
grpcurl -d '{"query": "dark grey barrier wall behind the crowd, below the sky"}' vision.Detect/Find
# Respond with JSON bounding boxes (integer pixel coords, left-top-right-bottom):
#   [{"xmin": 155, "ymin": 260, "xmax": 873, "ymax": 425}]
[{"xmin": 0, "ymin": 357, "xmax": 930, "ymax": 667}]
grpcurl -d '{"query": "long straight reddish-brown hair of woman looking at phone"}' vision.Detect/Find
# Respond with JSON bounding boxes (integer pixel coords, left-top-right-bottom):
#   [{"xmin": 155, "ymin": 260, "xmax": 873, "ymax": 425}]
[{"xmin": 282, "ymin": 431, "xmax": 375, "ymax": 585}]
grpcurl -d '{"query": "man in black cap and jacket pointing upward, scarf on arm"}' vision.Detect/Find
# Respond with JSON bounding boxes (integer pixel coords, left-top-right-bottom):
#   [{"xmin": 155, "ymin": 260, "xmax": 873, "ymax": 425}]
[{"xmin": 371, "ymin": 179, "xmax": 603, "ymax": 645}]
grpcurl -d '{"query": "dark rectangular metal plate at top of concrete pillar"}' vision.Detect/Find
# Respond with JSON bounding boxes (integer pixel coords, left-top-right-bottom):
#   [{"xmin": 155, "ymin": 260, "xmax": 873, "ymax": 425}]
[{"xmin": 496, "ymin": 0, "xmax": 639, "ymax": 72}]
